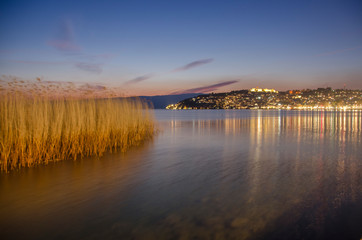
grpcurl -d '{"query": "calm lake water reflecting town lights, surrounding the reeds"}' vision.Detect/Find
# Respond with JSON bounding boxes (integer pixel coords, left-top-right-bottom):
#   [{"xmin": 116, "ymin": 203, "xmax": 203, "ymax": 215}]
[{"xmin": 0, "ymin": 110, "xmax": 362, "ymax": 240}]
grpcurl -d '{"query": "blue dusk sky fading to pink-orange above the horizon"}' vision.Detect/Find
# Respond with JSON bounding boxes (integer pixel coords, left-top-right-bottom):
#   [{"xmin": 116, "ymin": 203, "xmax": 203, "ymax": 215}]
[{"xmin": 0, "ymin": 0, "xmax": 362, "ymax": 95}]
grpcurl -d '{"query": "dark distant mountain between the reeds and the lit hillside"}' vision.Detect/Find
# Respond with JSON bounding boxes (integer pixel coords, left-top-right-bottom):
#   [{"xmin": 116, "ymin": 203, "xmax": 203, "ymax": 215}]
[{"xmin": 139, "ymin": 93, "xmax": 202, "ymax": 109}]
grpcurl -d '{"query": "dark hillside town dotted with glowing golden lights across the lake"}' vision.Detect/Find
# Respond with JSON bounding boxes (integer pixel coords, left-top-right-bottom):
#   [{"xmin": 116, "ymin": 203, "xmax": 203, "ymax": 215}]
[{"xmin": 166, "ymin": 88, "xmax": 362, "ymax": 110}]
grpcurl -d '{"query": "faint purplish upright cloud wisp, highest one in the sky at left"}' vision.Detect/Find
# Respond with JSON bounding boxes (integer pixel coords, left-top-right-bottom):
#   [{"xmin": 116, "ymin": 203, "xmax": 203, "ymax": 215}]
[{"xmin": 48, "ymin": 19, "xmax": 81, "ymax": 53}]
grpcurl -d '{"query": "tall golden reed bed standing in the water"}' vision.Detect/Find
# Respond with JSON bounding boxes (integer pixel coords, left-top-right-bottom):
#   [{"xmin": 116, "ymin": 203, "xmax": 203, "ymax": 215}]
[{"xmin": 0, "ymin": 93, "xmax": 154, "ymax": 172}]
